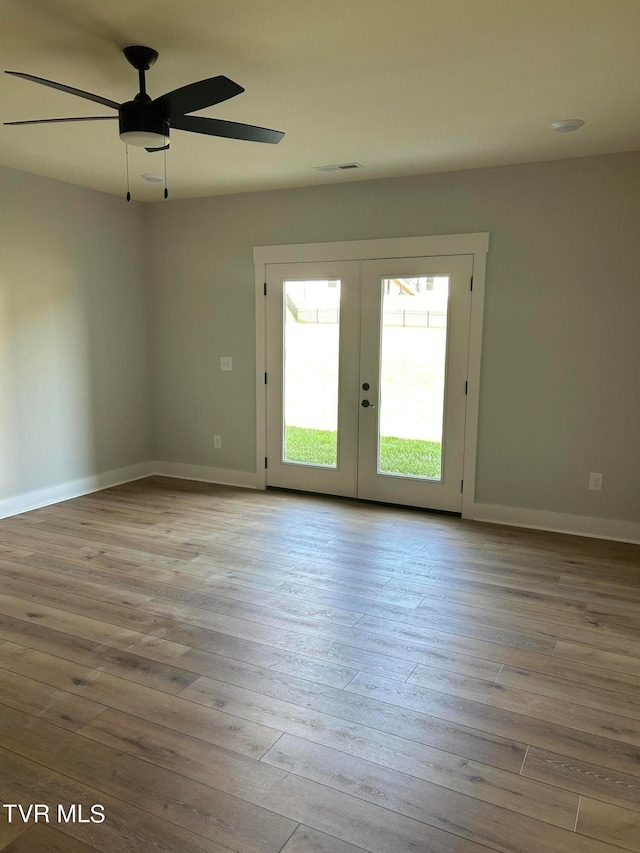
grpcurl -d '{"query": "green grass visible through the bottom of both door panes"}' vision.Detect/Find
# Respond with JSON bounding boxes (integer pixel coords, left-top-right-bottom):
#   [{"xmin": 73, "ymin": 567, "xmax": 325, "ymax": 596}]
[{"xmin": 286, "ymin": 427, "xmax": 441, "ymax": 478}]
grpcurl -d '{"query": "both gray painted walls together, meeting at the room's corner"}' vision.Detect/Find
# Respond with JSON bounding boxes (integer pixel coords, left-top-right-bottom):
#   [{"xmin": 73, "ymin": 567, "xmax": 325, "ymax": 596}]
[{"xmin": 0, "ymin": 153, "xmax": 640, "ymax": 521}]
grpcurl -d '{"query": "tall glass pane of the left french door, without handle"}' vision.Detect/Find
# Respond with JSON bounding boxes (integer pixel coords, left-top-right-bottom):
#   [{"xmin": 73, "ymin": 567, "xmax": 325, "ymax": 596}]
[{"xmin": 282, "ymin": 280, "xmax": 340, "ymax": 468}]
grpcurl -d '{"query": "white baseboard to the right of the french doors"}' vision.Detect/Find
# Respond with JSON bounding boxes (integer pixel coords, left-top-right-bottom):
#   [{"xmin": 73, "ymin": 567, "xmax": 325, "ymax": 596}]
[{"xmin": 465, "ymin": 503, "xmax": 640, "ymax": 544}]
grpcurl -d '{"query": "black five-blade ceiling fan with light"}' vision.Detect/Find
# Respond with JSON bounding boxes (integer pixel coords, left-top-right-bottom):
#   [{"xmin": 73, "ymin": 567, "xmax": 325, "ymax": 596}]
[{"xmin": 5, "ymin": 45, "xmax": 284, "ymax": 151}]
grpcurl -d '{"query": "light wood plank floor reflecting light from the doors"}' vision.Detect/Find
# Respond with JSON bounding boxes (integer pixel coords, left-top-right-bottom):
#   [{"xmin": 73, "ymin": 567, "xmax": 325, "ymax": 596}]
[{"xmin": 0, "ymin": 478, "xmax": 640, "ymax": 853}]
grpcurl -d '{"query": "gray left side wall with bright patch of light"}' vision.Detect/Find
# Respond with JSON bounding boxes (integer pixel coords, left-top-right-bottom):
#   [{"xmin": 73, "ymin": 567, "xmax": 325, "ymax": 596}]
[{"xmin": 0, "ymin": 168, "xmax": 150, "ymax": 499}]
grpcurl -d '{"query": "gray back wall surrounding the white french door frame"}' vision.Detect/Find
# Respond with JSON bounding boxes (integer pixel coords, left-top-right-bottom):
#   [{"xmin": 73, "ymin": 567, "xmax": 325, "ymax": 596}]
[{"xmin": 147, "ymin": 153, "xmax": 640, "ymax": 521}]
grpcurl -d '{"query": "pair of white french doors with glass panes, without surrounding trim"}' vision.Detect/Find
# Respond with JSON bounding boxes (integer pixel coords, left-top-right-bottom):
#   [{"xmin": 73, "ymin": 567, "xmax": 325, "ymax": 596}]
[{"xmin": 266, "ymin": 255, "xmax": 473, "ymax": 512}]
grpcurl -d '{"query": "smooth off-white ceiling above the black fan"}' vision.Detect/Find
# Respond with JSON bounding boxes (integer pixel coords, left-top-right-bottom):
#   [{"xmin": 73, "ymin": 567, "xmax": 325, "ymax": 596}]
[{"xmin": 0, "ymin": 0, "xmax": 640, "ymax": 201}]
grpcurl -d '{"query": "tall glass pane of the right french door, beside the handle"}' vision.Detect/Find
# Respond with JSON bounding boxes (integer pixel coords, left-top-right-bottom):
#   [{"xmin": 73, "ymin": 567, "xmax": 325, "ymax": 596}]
[{"xmin": 378, "ymin": 275, "xmax": 449, "ymax": 480}]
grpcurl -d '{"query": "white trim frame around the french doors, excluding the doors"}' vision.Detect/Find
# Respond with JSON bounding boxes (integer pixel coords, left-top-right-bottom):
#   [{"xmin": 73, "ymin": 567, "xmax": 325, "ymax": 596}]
[{"xmin": 253, "ymin": 232, "xmax": 489, "ymax": 518}]
